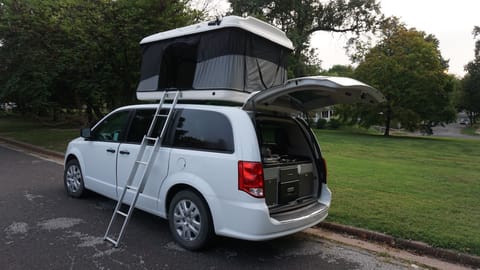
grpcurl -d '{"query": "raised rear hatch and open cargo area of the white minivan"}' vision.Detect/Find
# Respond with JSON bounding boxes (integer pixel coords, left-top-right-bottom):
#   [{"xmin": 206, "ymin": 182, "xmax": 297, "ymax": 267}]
[{"xmin": 243, "ymin": 76, "xmax": 384, "ymax": 215}]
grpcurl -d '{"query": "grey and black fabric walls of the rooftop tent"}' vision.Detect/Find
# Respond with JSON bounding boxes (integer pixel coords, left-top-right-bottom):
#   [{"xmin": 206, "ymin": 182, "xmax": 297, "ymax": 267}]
[{"xmin": 137, "ymin": 27, "xmax": 290, "ymax": 95}]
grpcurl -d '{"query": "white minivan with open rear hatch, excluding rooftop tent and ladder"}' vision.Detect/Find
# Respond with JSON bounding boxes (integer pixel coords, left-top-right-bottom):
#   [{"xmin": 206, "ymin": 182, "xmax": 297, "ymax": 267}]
[{"xmin": 64, "ymin": 77, "xmax": 383, "ymax": 250}]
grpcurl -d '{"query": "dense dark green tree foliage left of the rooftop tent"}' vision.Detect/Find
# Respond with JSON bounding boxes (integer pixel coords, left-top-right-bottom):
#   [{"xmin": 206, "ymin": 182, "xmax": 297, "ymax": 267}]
[{"xmin": 0, "ymin": 0, "xmax": 199, "ymax": 120}]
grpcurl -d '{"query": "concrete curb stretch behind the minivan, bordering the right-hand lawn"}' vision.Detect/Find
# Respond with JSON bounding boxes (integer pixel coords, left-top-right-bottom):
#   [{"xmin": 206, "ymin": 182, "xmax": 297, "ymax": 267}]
[{"xmin": 317, "ymin": 222, "xmax": 480, "ymax": 269}]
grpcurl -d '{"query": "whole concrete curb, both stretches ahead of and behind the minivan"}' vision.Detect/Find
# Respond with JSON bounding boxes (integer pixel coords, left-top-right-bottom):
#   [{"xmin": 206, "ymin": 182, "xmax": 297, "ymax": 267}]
[{"xmin": 0, "ymin": 137, "xmax": 480, "ymax": 269}]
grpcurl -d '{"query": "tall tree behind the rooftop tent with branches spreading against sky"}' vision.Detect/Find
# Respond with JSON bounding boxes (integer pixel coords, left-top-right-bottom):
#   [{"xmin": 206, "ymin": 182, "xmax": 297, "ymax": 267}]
[{"xmin": 230, "ymin": 0, "xmax": 383, "ymax": 77}]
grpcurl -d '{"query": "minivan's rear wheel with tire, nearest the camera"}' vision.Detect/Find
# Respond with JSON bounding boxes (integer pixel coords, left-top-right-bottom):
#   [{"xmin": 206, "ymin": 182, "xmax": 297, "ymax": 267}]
[{"xmin": 168, "ymin": 190, "xmax": 214, "ymax": 251}]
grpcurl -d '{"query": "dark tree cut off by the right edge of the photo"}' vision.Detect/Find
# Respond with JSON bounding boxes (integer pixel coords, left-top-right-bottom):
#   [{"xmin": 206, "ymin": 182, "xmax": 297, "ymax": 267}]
[{"xmin": 459, "ymin": 26, "xmax": 480, "ymax": 125}]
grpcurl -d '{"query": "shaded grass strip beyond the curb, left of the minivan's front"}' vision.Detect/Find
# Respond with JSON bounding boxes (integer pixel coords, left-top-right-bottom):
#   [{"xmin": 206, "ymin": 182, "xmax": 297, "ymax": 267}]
[{"xmin": 0, "ymin": 116, "xmax": 80, "ymax": 152}]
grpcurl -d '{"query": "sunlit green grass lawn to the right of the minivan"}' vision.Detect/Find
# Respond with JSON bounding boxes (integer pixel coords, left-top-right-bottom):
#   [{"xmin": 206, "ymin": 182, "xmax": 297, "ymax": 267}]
[{"xmin": 316, "ymin": 131, "xmax": 480, "ymax": 255}]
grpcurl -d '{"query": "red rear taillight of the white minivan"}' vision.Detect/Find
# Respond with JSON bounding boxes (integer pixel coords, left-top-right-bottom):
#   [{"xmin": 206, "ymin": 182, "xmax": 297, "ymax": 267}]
[{"xmin": 238, "ymin": 161, "xmax": 264, "ymax": 198}]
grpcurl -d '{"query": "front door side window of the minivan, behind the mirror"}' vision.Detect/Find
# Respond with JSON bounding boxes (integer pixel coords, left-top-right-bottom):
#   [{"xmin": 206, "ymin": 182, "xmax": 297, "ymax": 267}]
[{"xmin": 92, "ymin": 111, "xmax": 130, "ymax": 142}]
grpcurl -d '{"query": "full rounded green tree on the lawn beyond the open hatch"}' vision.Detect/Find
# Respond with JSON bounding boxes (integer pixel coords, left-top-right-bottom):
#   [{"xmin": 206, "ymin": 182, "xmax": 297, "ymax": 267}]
[{"xmin": 342, "ymin": 18, "xmax": 455, "ymax": 136}]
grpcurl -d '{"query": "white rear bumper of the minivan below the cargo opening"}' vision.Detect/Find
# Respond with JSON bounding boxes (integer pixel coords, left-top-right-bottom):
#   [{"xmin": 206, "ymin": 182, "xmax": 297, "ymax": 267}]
[{"xmin": 214, "ymin": 184, "xmax": 331, "ymax": 241}]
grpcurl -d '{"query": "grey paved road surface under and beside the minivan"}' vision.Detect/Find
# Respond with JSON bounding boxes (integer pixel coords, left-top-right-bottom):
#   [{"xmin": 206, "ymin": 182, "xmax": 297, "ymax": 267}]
[{"xmin": 0, "ymin": 145, "xmax": 409, "ymax": 270}]
